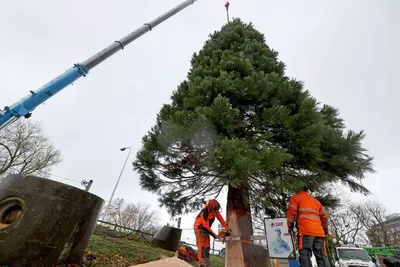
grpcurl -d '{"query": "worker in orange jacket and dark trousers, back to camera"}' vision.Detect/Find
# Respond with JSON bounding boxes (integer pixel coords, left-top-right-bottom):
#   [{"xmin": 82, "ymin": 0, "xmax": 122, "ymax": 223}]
[{"xmin": 287, "ymin": 186, "xmax": 329, "ymax": 267}]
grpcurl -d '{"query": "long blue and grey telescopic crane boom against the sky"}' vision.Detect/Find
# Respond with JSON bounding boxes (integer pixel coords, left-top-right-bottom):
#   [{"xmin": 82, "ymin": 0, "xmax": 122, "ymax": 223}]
[{"xmin": 0, "ymin": 0, "xmax": 197, "ymax": 130}]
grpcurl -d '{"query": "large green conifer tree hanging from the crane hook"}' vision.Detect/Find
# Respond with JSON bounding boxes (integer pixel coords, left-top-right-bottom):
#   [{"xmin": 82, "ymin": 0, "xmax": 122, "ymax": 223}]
[{"xmin": 134, "ymin": 19, "xmax": 373, "ymax": 266}]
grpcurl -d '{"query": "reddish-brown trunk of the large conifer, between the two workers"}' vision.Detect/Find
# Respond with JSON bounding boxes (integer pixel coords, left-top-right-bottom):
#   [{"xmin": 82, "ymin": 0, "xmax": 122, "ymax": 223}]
[{"xmin": 225, "ymin": 185, "xmax": 257, "ymax": 267}]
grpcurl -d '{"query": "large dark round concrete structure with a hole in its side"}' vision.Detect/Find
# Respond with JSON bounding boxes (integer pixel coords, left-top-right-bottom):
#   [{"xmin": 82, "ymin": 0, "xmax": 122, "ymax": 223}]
[{"xmin": 0, "ymin": 175, "xmax": 104, "ymax": 266}]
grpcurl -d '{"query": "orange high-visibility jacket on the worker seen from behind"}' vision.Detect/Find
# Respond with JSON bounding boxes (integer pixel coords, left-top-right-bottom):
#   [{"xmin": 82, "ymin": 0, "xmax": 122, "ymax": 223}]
[{"xmin": 287, "ymin": 191, "xmax": 328, "ymax": 237}]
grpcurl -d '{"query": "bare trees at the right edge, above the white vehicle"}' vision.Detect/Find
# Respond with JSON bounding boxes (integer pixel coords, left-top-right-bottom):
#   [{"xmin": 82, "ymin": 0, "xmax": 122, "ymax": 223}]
[{"xmin": 350, "ymin": 201, "xmax": 400, "ymax": 246}]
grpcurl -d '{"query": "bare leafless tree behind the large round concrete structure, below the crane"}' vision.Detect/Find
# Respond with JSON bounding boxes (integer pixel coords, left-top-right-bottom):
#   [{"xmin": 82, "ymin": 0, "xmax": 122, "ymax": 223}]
[{"xmin": 0, "ymin": 120, "xmax": 62, "ymax": 180}]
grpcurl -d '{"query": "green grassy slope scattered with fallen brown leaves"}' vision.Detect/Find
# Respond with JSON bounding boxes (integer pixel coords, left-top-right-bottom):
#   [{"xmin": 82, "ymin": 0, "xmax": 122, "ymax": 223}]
[{"xmin": 84, "ymin": 235, "xmax": 225, "ymax": 267}]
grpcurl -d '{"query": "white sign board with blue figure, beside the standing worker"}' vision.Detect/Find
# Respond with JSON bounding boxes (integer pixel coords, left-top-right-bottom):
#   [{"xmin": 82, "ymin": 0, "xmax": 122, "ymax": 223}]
[{"xmin": 264, "ymin": 218, "xmax": 296, "ymax": 259}]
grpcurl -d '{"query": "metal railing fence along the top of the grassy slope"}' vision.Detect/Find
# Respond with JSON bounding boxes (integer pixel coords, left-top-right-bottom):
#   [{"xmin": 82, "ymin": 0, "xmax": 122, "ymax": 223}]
[{"xmin": 95, "ymin": 220, "xmax": 220, "ymax": 255}]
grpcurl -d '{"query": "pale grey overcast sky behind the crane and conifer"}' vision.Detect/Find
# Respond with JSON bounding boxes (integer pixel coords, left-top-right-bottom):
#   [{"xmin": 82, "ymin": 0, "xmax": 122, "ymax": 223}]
[{"xmin": 0, "ymin": 0, "xmax": 400, "ymax": 249}]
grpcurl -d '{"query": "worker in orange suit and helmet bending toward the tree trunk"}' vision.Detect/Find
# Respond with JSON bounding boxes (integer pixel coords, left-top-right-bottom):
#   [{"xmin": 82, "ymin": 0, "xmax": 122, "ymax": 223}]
[{"xmin": 194, "ymin": 199, "xmax": 229, "ymax": 267}]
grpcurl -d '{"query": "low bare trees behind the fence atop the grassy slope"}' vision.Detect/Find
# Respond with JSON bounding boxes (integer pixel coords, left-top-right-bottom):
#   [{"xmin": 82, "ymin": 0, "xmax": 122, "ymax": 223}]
[{"xmin": 105, "ymin": 198, "xmax": 160, "ymax": 233}]
